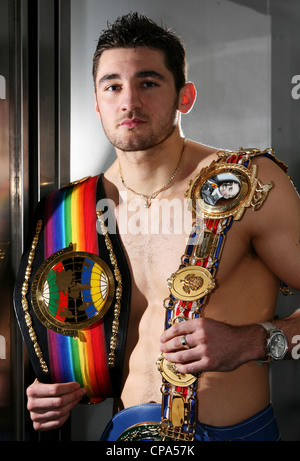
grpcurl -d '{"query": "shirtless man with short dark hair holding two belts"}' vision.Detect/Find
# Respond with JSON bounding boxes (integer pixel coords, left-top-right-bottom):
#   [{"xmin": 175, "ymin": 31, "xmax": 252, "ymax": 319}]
[{"xmin": 21, "ymin": 14, "xmax": 300, "ymax": 440}]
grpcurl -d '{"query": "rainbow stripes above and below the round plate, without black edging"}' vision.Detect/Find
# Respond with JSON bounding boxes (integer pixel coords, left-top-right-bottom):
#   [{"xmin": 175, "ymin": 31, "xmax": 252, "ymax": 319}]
[{"xmin": 44, "ymin": 177, "xmax": 112, "ymax": 403}]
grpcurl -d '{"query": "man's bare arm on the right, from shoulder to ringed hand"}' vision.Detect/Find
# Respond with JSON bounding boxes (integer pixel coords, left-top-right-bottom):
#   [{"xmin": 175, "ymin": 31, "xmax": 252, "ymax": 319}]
[{"xmin": 161, "ymin": 158, "xmax": 300, "ymax": 373}]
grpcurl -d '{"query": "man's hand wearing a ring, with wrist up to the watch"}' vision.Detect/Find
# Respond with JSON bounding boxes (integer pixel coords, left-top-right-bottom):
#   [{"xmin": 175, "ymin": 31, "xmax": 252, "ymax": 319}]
[{"xmin": 161, "ymin": 318, "xmax": 265, "ymax": 374}]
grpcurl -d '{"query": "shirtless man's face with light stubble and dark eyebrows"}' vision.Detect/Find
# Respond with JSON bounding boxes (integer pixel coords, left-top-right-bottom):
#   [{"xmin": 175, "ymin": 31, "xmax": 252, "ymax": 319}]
[{"xmin": 96, "ymin": 47, "xmax": 179, "ymax": 151}]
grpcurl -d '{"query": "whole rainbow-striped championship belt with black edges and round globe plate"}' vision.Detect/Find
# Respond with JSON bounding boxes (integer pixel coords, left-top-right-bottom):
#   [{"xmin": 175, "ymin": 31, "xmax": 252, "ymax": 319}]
[{"xmin": 15, "ymin": 176, "xmax": 130, "ymax": 403}]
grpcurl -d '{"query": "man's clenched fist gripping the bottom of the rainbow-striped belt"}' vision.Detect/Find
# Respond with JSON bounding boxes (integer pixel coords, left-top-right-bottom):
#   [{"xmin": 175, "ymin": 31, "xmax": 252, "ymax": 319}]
[{"xmin": 27, "ymin": 380, "xmax": 86, "ymax": 431}]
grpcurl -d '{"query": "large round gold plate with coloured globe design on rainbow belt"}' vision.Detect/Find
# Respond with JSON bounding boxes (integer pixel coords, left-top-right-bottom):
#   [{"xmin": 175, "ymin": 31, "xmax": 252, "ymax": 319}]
[{"xmin": 31, "ymin": 246, "xmax": 115, "ymax": 336}]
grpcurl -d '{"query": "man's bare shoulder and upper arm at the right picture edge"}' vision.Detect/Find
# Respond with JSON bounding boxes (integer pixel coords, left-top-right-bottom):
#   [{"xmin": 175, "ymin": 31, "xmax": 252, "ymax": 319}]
[{"xmin": 248, "ymin": 158, "xmax": 300, "ymax": 290}]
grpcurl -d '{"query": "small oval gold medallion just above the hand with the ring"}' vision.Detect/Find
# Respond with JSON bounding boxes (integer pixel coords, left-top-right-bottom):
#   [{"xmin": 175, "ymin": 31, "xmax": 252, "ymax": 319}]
[{"xmin": 168, "ymin": 266, "xmax": 215, "ymax": 301}]
